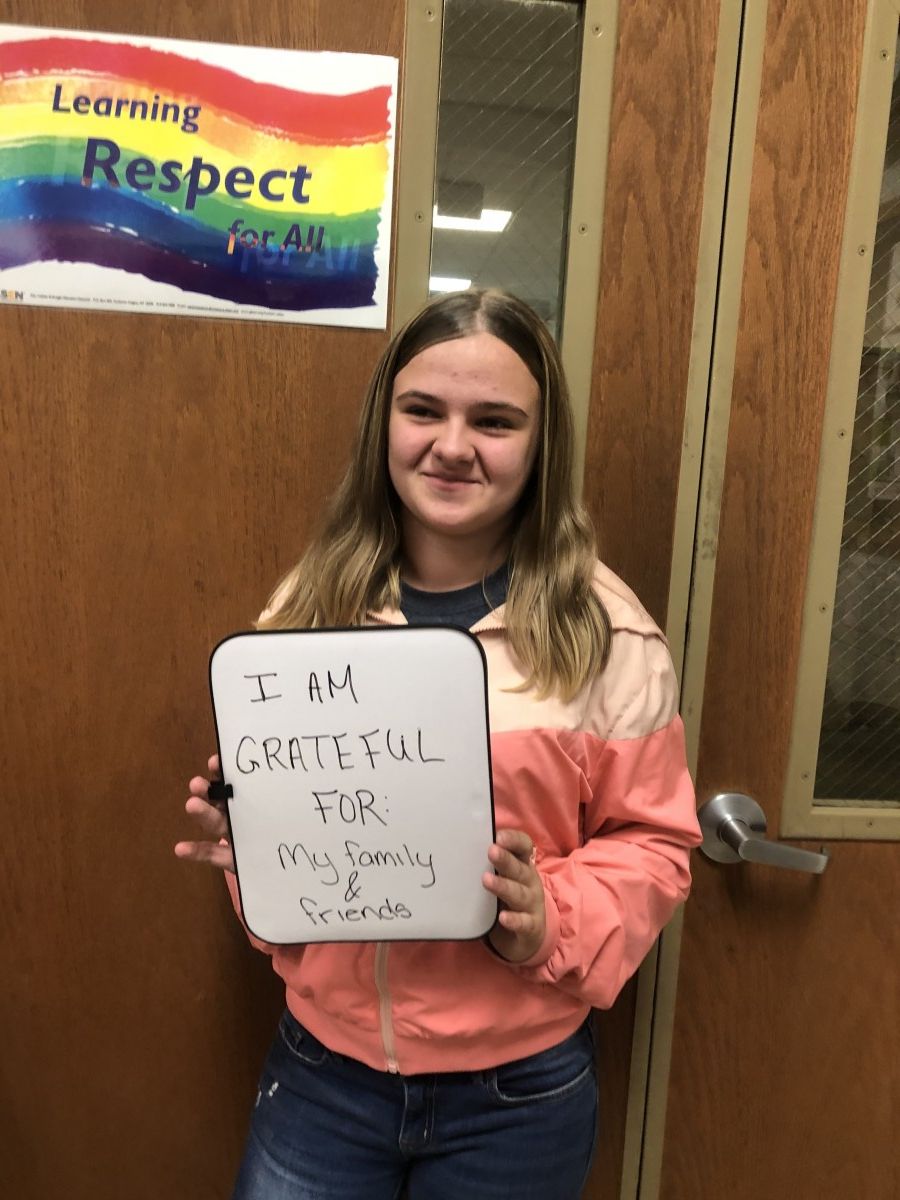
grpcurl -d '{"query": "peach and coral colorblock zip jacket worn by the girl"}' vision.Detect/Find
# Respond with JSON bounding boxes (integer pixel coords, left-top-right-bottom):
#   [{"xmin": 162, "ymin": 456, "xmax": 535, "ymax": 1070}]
[{"xmin": 227, "ymin": 564, "xmax": 700, "ymax": 1074}]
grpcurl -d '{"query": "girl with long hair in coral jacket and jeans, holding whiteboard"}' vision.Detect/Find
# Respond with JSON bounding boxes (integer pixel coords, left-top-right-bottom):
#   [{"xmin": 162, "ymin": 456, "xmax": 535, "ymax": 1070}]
[{"xmin": 175, "ymin": 290, "xmax": 700, "ymax": 1200}]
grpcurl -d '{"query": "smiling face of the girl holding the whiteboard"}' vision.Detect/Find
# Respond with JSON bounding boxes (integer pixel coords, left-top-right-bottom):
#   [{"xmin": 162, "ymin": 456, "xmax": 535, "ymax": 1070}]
[{"xmin": 388, "ymin": 332, "xmax": 540, "ymax": 546}]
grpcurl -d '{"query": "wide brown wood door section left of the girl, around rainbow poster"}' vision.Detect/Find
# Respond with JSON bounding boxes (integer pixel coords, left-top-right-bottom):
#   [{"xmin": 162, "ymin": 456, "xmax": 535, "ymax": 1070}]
[{"xmin": 0, "ymin": 0, "xmax": 403, "ymax": 1200}]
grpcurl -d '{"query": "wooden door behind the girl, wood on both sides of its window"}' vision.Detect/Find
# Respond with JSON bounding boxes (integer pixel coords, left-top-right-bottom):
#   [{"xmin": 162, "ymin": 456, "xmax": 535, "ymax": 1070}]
[{"xmin": 0, "ymin": 0, "xmax": 768, "ymax": 1200}]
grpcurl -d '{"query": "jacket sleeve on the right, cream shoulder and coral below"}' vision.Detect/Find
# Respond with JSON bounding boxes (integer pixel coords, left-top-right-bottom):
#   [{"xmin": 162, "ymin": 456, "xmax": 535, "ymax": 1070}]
[{"xmin": 514, "ymin": 631, "xmax": 701, "ymax": 1008}]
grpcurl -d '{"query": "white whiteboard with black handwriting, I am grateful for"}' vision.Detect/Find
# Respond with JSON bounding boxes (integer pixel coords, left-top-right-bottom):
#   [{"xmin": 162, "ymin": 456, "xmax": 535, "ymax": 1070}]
[{"xmin": 210, "ymin": 626, "xmax": 497, "ymax": 943}]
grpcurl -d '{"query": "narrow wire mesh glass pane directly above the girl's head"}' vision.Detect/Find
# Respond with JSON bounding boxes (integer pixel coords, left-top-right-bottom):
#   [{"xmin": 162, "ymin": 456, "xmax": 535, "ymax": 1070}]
[{"xmin": 431, "ymin": 0, "xmax": 583, "ymax": 331}]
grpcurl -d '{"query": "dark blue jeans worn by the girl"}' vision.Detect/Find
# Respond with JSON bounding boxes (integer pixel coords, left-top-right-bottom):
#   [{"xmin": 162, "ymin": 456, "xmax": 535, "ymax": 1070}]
[{"xmin": 233, "ymin": 1012, "xmax": 596, "ymax": 1200}]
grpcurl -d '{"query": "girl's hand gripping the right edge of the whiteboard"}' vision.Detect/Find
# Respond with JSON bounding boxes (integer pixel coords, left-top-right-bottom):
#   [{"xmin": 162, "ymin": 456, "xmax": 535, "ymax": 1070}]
[{"xmin": 481, "ymin": 829, "xmax": 547, "ymax": 962}]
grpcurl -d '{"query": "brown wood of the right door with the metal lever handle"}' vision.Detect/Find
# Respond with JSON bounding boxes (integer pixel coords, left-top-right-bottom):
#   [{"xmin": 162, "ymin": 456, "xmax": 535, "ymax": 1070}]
[{"xmin": 646, "ymin": 0, "xmax": 900, "ymax": 1200}]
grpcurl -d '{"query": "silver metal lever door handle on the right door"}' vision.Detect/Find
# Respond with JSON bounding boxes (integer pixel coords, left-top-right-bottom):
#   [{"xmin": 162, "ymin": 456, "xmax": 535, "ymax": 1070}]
[{"xmin": 697, "ymin": 792, "xmax": 828, "ymax": 875}]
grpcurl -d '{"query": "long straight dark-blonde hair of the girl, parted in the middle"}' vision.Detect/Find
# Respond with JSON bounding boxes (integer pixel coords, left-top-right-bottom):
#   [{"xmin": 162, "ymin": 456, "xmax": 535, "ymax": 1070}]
[{"xmin": 259, "ymin": 289, "xmax": 611, "ymax": 698}]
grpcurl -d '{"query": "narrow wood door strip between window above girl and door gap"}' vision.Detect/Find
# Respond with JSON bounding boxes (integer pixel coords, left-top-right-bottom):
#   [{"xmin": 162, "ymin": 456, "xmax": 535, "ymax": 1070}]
[{"xmin": 584, "ymin": 0, "xmax": 738, "ymax": 1200}]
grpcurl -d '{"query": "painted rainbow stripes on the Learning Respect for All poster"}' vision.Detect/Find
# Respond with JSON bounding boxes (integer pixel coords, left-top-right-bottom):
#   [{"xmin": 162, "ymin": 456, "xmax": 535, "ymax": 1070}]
[{"xmin": 0, "ymin": 36, "xmax": 390, "ymax": 311}]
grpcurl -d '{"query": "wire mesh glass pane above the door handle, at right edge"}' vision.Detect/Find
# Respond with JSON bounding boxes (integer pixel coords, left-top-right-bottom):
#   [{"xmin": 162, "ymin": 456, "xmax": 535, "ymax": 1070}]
[{"xmin": 815, "ymin": 35, "xmax": 900, "ymax": 806}]
